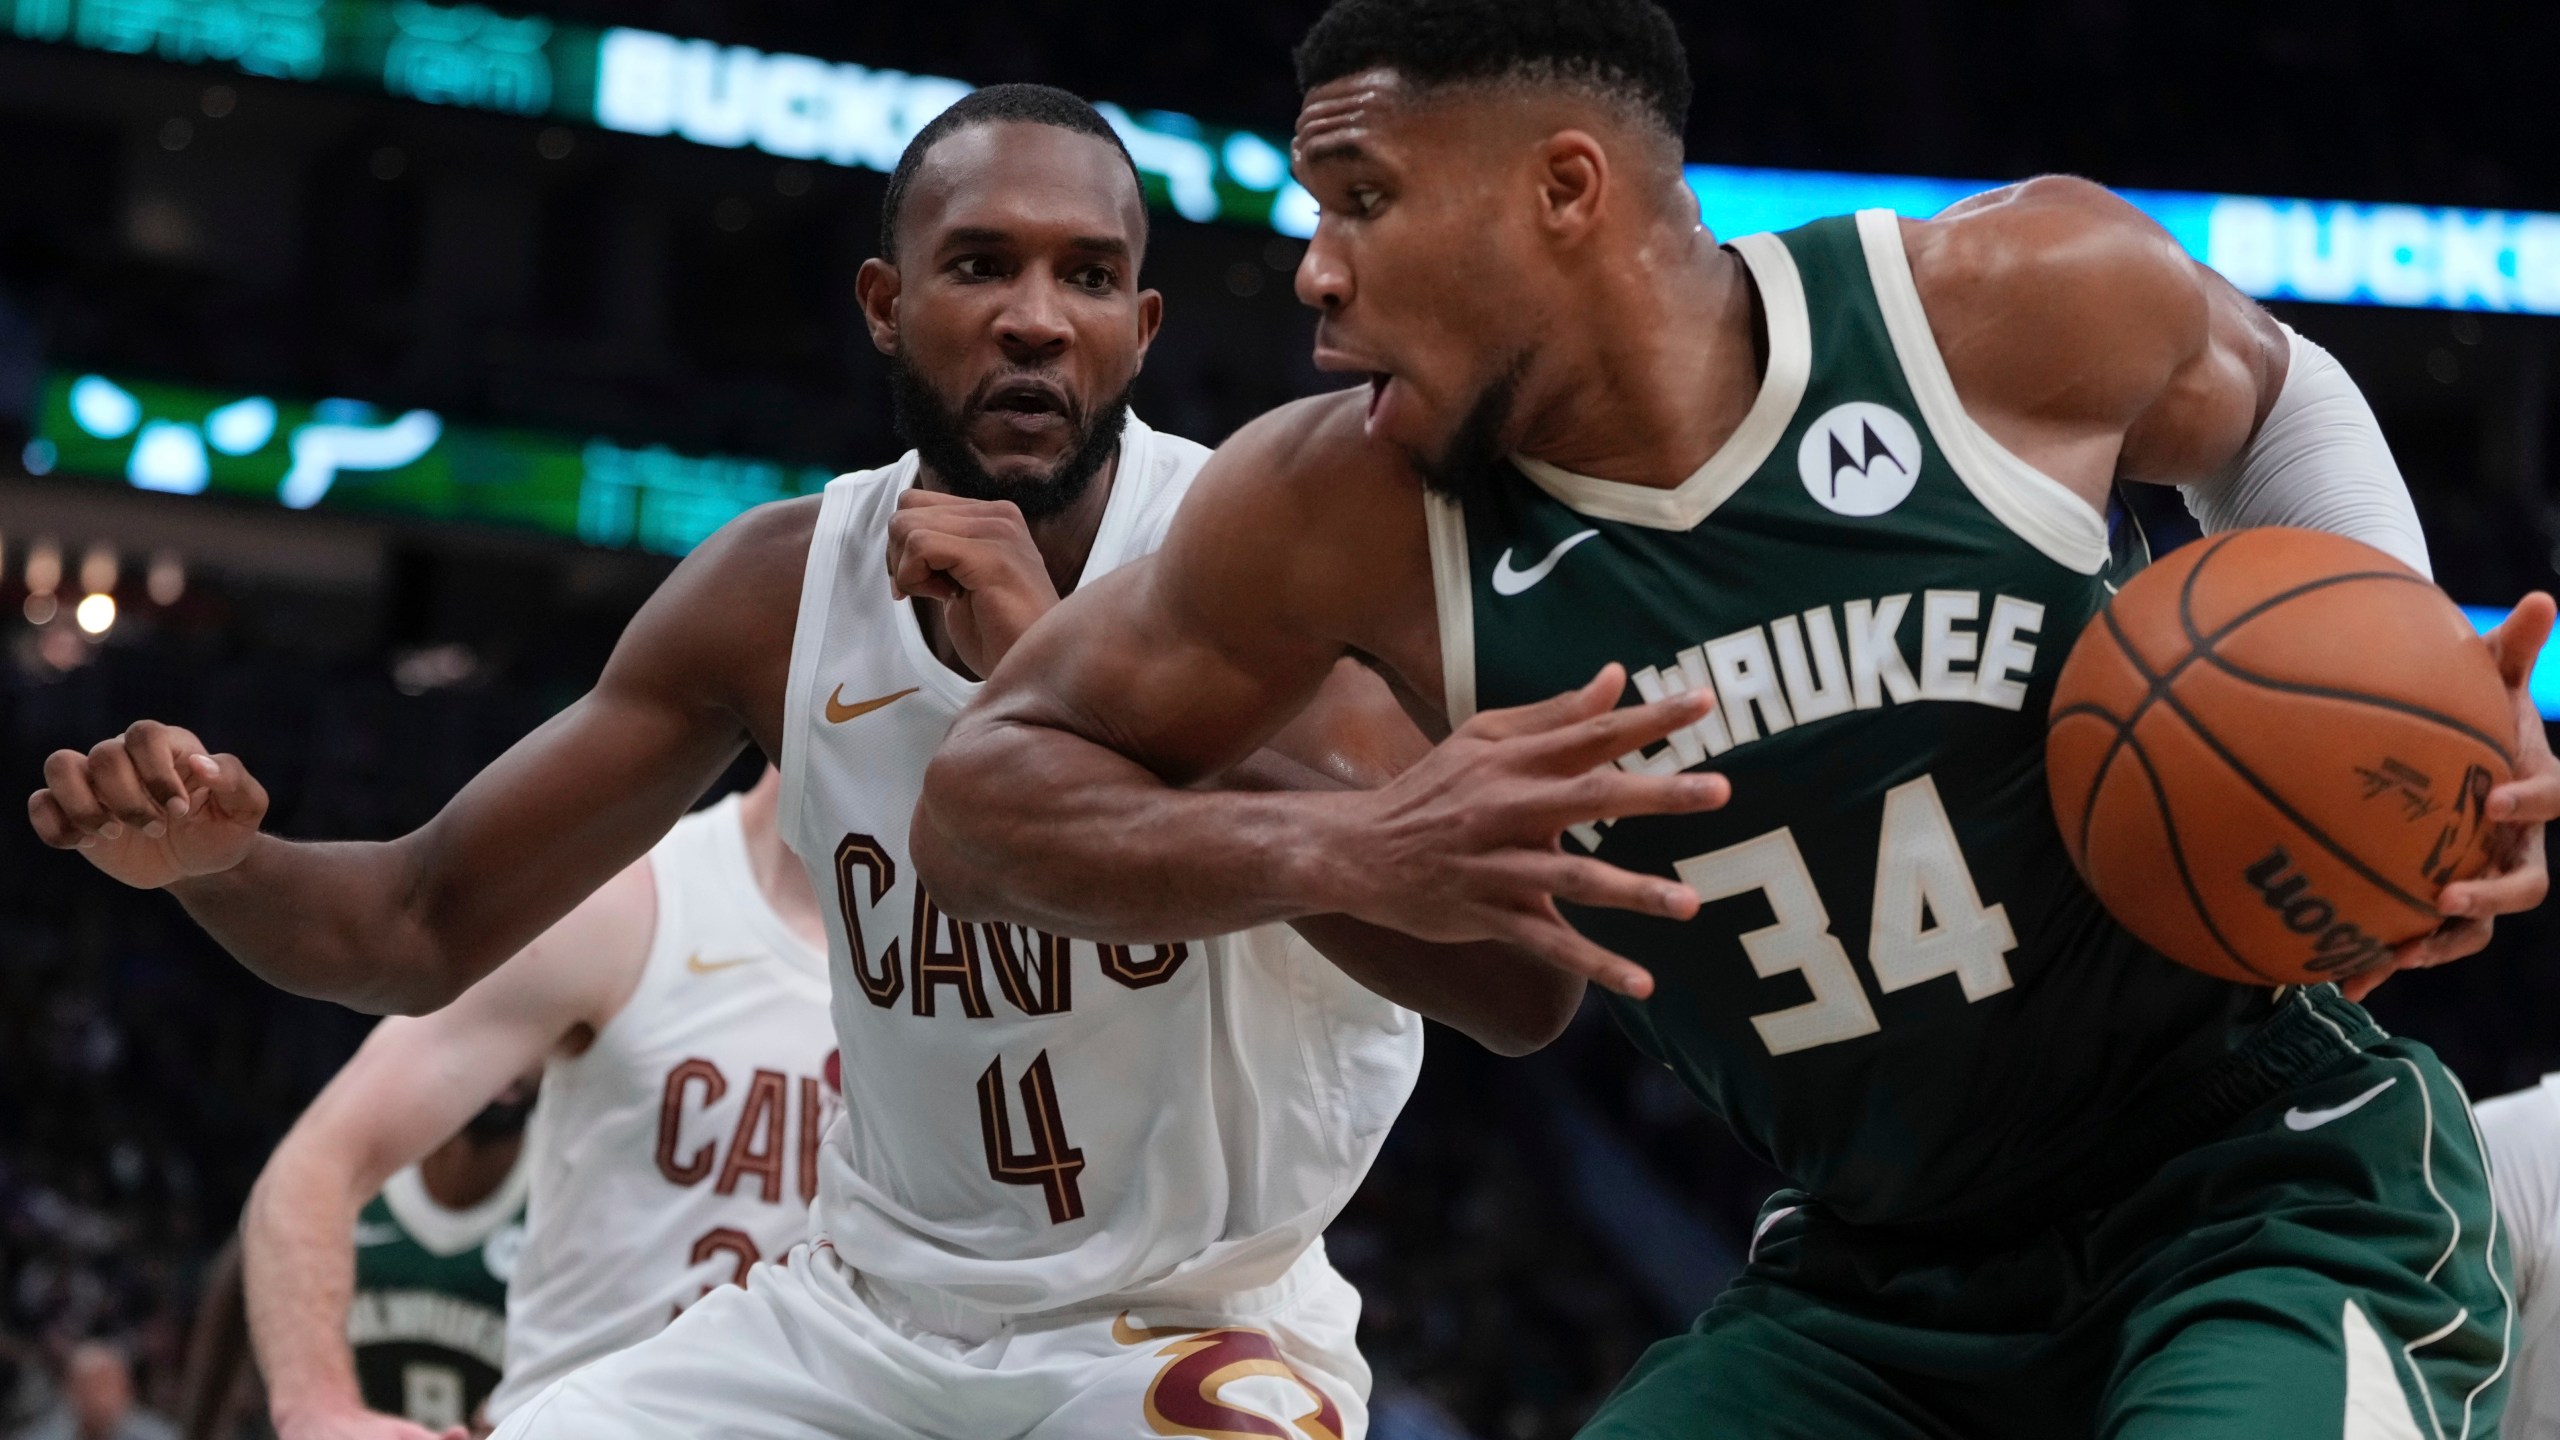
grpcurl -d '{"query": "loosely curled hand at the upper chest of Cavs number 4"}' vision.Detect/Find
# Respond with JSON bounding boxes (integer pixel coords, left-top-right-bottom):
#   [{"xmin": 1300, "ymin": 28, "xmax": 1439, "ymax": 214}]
[{"xmin": 888, "ymin": 489, "xmax": 1057, "ymax": 676}]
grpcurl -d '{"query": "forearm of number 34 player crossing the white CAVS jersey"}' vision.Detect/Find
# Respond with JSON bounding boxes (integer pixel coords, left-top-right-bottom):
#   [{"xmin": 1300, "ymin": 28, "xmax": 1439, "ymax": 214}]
[{"xmin": 911, "ymin": 715, "xmax": 1359, "ymax": 943}]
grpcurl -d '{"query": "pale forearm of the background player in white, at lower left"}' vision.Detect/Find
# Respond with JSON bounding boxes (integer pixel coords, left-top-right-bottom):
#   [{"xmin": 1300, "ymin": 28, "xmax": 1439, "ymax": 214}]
[{"xmin": 241, "ymin": 1138, "xmax": 364, "ymax": 1430}]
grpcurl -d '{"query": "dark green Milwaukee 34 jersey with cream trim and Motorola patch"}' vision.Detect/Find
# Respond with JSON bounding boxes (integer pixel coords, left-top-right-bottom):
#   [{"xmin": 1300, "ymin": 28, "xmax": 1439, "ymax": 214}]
[{"xmin": 1431, "ymin": 210, "xmax": 2268, "ymax": 1225}]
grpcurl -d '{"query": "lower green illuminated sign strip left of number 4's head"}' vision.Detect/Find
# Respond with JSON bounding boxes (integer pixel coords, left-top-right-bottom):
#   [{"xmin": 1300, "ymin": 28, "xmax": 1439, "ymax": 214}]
[{"xmin": 26, "ymin": 363, "xmax": 829, "ymax": 556}]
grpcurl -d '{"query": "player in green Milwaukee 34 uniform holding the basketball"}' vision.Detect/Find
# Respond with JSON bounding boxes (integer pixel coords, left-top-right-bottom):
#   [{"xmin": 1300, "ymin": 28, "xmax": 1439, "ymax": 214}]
[{"xmin": 914, "ymin": 0, "xmax": 2560, "ymax": 1440}]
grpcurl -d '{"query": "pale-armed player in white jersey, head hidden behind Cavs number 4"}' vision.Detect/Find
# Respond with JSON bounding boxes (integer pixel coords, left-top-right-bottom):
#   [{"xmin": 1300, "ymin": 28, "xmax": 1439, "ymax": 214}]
[{"xmin": 241, "ymin": 769, "xmax": 837, "ymax": 1440}]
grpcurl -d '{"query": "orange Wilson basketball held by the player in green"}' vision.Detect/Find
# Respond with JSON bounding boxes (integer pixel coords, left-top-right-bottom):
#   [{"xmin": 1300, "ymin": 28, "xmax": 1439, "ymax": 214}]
[{"xmin": 2045, "ymin": 530, "xmax": 2516, "ymax": 984}]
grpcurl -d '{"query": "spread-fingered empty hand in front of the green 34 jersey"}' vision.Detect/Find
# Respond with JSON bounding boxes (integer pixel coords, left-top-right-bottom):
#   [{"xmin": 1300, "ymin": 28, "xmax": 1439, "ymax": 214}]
[{"xmin": 1334, "ymin": 664, "xmax": 1733, "ymax": 999}]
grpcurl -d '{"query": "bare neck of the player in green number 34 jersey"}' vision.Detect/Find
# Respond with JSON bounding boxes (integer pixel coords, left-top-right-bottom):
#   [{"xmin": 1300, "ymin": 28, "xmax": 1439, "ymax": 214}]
[{"xmin": 1518, "ymin": 231, "xmax": 1769, "ymax": 489}]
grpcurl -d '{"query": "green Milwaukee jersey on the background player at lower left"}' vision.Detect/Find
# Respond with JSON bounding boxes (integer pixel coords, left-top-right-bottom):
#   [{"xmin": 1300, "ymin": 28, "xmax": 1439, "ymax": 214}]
[{"xmin": 346, "ymin": 1161, "xmax": 527, "ymax": 1430}]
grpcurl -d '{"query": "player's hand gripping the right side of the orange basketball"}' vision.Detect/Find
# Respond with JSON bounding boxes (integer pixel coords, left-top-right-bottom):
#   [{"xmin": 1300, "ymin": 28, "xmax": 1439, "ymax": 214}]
[{"xmin": 2342, "ymin": 589, "xmax": 2560, "ymax": 999}]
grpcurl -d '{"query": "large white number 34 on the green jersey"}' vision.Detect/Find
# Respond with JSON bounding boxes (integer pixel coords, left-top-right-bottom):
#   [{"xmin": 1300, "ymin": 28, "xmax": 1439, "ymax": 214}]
[{"xmin": 1674, "ymin": 776, "xmax": 2017, "ymax": 1056}]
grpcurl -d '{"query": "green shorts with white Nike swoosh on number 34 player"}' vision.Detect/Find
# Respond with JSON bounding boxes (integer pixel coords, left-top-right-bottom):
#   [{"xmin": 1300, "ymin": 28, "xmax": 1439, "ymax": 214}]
[{"xmin": 1582, "ymin": 986, "xmax": 2516, "ymax": 1440}]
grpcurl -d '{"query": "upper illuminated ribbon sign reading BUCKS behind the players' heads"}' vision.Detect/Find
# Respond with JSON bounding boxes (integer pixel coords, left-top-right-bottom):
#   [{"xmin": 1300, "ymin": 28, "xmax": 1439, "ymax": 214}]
[{"xmin": 15, "ymin": 0, "xmax": 2560, "ymax": 315}]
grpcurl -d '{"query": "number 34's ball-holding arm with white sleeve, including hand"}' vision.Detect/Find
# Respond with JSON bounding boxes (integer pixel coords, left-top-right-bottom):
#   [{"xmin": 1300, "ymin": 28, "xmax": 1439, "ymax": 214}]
[{"xmin": 1905, "ymin": 177, "xmax": 2560, "ymax": 963}]
